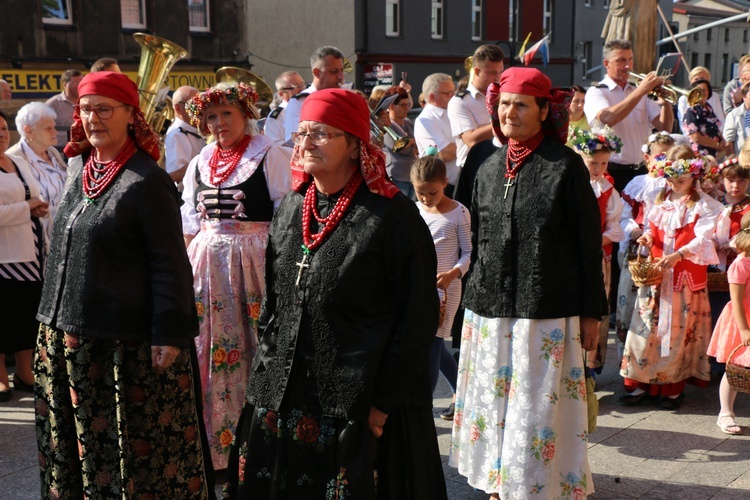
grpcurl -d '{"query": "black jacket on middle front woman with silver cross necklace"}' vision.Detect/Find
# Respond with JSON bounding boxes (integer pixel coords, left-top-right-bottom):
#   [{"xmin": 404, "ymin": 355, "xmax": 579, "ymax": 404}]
[{"xmin": 247, "ymin": 183, "xmax": 439, "ymax": 419}]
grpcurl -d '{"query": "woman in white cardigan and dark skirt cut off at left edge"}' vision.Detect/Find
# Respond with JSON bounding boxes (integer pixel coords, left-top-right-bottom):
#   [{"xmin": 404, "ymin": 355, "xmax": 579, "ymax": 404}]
[{"xmin": 0, "ymin": 111, "xmax": 48, "ymax": 402}]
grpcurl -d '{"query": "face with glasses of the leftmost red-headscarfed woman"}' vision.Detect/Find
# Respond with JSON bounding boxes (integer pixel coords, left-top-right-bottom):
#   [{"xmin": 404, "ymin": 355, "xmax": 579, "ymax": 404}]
[{"xmin": 78, "ymin": 95, "xmax": 134, "ymax": 156}]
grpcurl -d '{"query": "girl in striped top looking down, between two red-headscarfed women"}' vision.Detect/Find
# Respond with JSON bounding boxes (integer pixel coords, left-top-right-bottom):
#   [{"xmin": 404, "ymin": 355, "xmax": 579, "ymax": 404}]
[{"xmin": 411, "ymin": 156, "xmax": 471, "ymax": 420}]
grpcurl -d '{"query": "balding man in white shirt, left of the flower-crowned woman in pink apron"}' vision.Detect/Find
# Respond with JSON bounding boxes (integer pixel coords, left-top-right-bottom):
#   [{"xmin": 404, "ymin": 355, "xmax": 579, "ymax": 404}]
[{"xmin": 164, "ymin": 86, "xmax": 206, "ymax": 184}]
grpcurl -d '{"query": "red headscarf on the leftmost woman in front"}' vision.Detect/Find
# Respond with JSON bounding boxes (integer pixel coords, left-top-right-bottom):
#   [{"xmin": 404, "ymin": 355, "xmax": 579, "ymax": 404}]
[{"xmin": 64, "ymin": 71, "xmax": 159, "ymax": 161}]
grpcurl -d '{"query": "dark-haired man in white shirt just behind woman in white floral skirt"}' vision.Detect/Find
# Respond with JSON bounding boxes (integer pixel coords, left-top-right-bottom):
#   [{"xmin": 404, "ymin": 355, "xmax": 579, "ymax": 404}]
[{"xmin": 448, "ymin": 44, "xmax": 505, "ymax": 168}]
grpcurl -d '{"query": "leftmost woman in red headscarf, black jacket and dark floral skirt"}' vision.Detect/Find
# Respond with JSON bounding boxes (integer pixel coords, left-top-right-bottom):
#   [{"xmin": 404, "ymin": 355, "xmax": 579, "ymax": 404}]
[{"xmin": 34, "ymin": 71, "xmax": 213, "ymax": 498}]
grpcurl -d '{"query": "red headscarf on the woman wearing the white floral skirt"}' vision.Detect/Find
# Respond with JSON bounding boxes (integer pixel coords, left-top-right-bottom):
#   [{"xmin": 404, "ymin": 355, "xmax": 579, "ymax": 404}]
[{"xmin": 486, "ymin": 66, "xmax": 573, "ymax": 144}]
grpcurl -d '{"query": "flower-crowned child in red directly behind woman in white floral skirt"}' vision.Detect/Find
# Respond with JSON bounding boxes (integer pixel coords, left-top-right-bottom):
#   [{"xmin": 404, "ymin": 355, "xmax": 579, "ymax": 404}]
[{"xmin": 570, "ymin": 128, "xmax": 625, "ymax": 373}]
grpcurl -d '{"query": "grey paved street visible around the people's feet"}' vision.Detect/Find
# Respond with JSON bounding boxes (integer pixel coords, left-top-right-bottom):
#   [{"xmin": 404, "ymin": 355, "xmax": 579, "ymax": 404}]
[{"xmin": 0, "ymin": 334, "xmax": 750, "ymax": 500}]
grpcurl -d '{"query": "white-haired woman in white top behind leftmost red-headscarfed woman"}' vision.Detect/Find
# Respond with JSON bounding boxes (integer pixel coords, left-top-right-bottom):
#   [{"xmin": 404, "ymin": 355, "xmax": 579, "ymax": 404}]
[{"xmin": 7, "ymin": 102, "xmax": 67, "ymax": 244}]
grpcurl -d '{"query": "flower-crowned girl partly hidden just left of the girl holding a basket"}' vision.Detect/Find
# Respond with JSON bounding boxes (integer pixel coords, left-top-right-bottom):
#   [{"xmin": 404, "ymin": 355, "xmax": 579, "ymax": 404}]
[{"xmin": 615, "ymin": 132, "xmax": 674, "ymax": 357}]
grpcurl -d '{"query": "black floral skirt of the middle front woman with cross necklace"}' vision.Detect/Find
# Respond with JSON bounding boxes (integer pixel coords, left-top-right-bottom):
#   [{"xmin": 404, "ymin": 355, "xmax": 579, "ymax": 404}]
[{"xmin": 223, "ymin": 369, "xmax": 447, "ymax": 500}]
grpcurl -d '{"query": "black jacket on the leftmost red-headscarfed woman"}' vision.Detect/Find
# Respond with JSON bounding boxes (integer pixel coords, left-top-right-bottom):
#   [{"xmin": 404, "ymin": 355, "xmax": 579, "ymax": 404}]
[{"xmin": 37, "ymin": 151, "xmax": 198, "ymax": 347}]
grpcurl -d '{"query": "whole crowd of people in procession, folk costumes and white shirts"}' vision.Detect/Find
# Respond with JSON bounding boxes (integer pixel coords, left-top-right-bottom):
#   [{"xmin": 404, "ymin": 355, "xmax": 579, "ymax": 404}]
[{"xmin": 0, "ymin": 39, "xmax": 750, "ymax": 500}]
